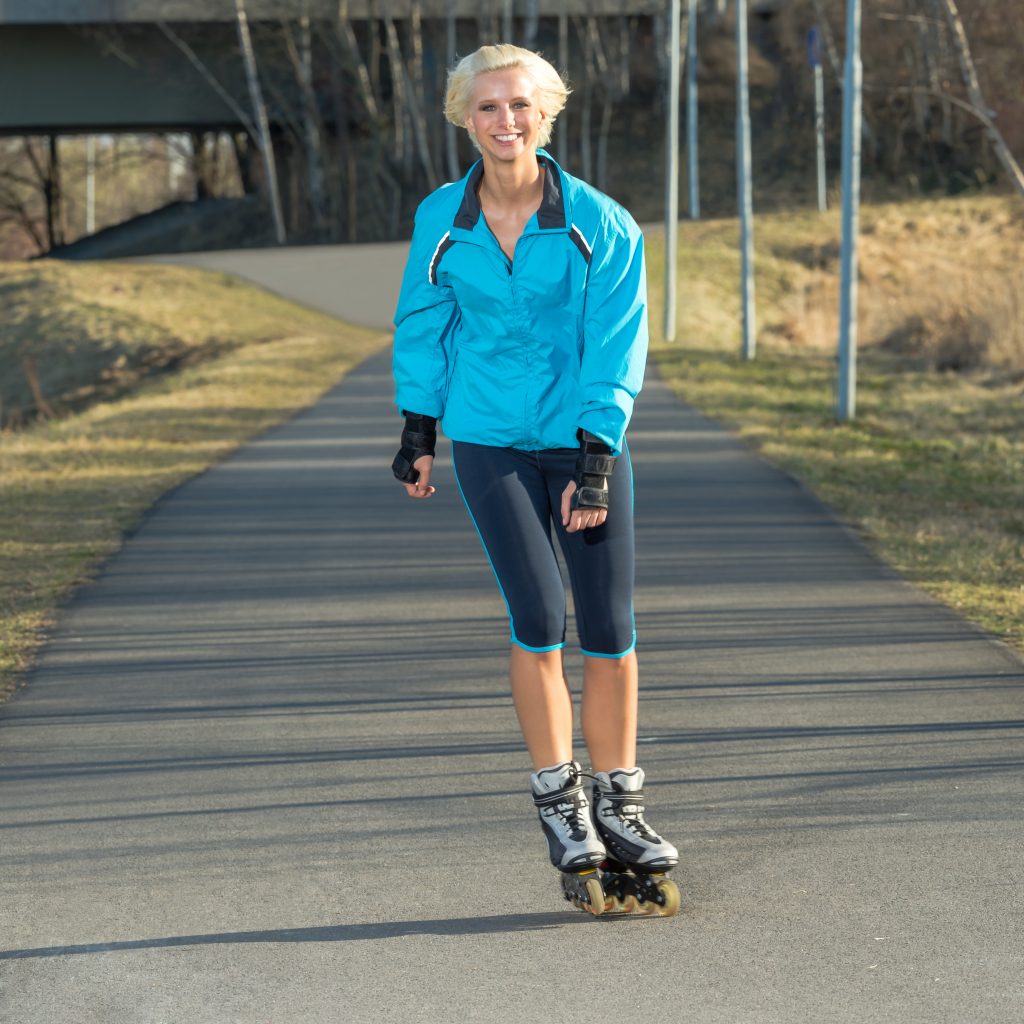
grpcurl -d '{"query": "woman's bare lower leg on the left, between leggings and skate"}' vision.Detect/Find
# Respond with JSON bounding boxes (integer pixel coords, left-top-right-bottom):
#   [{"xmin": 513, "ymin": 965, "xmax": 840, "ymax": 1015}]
[{"xmin": 509, "ymin": 645, "xmax": 572, "ymax": 770}]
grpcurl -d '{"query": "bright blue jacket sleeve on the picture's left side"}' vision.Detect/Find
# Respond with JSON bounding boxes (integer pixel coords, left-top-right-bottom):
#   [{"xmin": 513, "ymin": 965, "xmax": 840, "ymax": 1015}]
[{"xmin": 391, "ymin": 205, "xmax": 460, "ymax": 419}]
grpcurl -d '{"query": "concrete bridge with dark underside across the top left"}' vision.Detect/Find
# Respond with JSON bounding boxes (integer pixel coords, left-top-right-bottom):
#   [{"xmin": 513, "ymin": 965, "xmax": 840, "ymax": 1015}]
[{"xmin": 0, "ymin": 0, "xmax": 662, "ymax": 135}]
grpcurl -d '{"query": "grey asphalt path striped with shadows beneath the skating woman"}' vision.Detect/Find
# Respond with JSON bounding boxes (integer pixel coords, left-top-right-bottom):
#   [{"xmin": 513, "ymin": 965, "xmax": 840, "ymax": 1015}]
[{"xmin": 0, "ymin": 243, "xmax": 1024, "ymax": 1024}]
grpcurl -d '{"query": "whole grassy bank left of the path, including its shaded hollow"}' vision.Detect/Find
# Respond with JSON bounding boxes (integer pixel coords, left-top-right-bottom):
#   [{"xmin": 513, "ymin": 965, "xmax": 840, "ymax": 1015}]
[{"xmin": 0, "ymin": 262, "xmax": 388, "ymax": 697}]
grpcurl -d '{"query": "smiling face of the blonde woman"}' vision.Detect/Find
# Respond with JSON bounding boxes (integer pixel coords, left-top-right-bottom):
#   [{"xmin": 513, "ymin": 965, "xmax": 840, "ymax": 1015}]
[{"xmin": 466, "ymin": 68, "xmax": 545, "ymax": 162}]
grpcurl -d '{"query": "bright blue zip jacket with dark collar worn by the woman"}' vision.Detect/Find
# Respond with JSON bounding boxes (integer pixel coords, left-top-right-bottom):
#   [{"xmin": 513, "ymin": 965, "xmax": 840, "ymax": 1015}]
[{"xmin": 393, "ymin": 150, "xmax": 647, "ymax": 454}]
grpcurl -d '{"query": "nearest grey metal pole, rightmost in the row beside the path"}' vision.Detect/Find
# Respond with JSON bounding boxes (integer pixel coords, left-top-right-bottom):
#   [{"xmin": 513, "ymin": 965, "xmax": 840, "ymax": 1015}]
[{"xmin": 836, "ymin": 0, "xmax": 862, "ymax": 421}]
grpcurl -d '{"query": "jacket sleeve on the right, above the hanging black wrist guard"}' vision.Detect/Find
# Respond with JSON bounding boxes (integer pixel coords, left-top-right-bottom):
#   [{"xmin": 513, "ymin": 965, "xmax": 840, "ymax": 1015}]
[{"xmin": 577, "ymin": 211, "xmax": 647, "ymax": 455}]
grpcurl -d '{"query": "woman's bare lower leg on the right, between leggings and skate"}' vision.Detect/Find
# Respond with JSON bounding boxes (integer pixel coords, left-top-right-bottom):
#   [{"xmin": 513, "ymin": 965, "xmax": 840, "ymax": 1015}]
[{"xmin": 583, "ymin": 652, "xmax": 639, "ymax": 771}]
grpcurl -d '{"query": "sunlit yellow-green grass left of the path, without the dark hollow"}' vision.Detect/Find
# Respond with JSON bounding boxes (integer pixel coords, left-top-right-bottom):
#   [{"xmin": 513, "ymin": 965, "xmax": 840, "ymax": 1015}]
[{"xmin": 0, "ymin": 264, "xmax": 389, "ymax": 692}]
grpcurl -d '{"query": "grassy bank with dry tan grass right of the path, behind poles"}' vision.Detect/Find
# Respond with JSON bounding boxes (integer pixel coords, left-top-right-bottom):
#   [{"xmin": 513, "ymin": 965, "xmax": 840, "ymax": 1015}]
[{"xmin": 649, "ymin": 191, "xmax": 1024, "ymax": 649}]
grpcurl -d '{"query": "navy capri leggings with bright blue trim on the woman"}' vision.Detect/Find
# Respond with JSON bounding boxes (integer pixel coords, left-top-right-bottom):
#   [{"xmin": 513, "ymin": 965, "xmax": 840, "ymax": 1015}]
[{"xmin": 452, "ymin": 441, "xmax": 636, "ymax": 657}]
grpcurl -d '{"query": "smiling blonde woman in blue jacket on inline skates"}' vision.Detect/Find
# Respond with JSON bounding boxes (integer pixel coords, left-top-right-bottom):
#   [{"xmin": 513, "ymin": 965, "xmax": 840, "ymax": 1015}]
[{"xmin": 392, "ymin": 45, "xmax": 678, "ymax": 913}]
